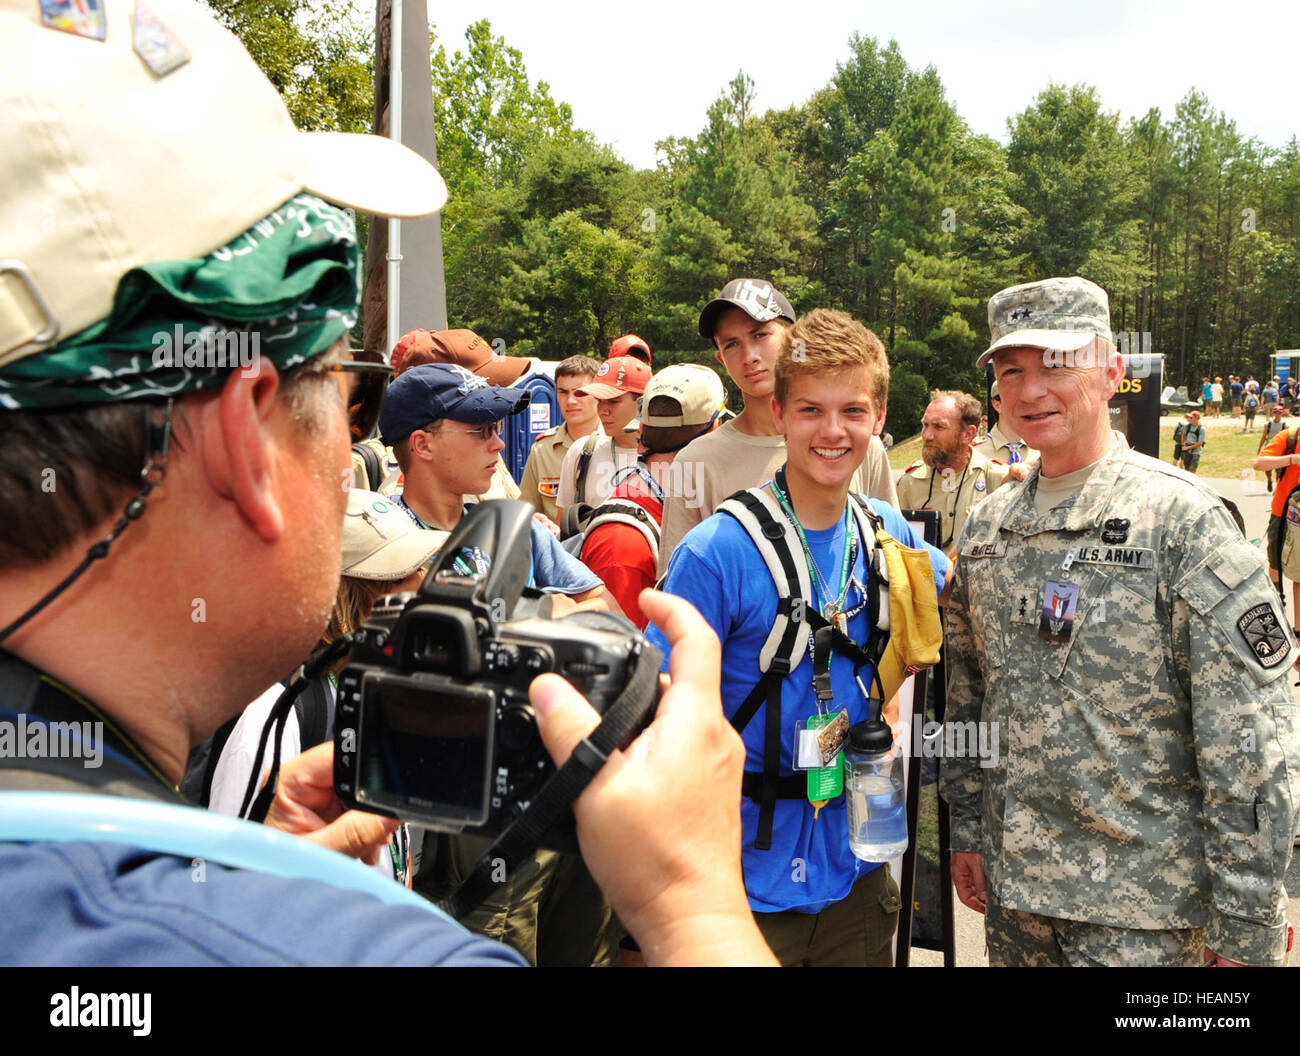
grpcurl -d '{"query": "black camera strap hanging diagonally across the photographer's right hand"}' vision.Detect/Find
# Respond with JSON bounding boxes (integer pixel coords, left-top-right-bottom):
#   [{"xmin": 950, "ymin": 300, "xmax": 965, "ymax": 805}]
[{"xmin": 438, "ymin": 641, "xmax": 663, "ymax": 921}]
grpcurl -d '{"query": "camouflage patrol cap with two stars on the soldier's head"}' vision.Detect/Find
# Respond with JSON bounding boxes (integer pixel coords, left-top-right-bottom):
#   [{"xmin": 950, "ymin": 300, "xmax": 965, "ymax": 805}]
[{"xmin": 975, "ymin": 276, "xmax": 1112, "ymax": 367}]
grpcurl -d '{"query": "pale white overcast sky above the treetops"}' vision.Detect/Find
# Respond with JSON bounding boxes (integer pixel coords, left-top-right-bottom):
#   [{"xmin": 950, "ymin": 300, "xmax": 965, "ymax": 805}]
[{"xmin": 421, "ymin": 0, "xmax": 1300, "ymax": 168}]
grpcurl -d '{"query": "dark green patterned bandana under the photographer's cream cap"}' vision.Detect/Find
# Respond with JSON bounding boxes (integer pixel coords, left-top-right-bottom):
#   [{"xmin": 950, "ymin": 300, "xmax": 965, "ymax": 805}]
[{"xmin": 0, "ymin": 194, "xmax": 360, "ymax": 410}]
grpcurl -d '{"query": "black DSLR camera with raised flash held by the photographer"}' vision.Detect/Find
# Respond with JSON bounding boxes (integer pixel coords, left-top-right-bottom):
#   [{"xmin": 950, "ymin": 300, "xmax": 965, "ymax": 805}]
[{"xmin": 334, "ymin": 501, "xmax": 660, "ymax": 851}]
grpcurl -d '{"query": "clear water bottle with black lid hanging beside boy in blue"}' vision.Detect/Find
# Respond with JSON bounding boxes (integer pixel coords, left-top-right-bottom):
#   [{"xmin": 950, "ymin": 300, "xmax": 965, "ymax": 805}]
[{"xmin": 844, "ymin": 719, "xmax": 907, "ymax": 862}]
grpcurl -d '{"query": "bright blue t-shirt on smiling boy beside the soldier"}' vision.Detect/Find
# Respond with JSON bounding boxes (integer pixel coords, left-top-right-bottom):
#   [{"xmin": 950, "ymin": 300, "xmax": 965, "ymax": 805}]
[{"xmin": 646, "ymin": 499, "xmax": 948, "ymax": 913}]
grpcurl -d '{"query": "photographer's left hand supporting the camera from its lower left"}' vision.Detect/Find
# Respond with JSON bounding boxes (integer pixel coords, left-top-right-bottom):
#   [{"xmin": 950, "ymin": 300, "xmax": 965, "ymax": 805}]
[{"xmin": 265, "ymin": 741, "xmax": 400, "ymax": 865}]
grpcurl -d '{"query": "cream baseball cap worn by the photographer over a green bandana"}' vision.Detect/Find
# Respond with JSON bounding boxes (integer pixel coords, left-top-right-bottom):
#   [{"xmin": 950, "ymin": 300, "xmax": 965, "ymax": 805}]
[{"xmin": 0, "ymin": 0, "xmax": 447, "ymax": 365}]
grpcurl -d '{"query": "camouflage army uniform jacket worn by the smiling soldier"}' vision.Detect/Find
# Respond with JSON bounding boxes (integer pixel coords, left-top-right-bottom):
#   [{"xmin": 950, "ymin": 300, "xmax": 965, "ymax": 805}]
[{"xmin": 943, "ymin": 437, "xmax": 1300, "ymax": 964}]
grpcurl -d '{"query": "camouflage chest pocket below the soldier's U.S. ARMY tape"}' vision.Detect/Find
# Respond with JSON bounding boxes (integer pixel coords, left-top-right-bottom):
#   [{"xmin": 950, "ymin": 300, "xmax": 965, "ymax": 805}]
[{"xmin": 1052, "ymin": 564, "xmax": 1167, "ymax": 715}]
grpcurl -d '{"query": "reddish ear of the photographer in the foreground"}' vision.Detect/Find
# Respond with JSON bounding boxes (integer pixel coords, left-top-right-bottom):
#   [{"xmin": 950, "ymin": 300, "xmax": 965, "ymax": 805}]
[{"xmin": 194, "ymin": 356, "xmax": 285, "ymax": 542}]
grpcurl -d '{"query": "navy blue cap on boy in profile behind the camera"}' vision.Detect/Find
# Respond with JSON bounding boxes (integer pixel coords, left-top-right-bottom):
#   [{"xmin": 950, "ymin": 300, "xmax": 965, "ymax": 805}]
[{"xmin": 380, "ymin": 363, "xmax": 532, "ymax": 447}]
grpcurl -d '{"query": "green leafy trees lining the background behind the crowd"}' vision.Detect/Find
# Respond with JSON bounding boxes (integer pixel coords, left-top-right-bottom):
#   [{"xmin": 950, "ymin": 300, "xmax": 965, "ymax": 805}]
[{"xmin": 209, "ymin": 13, "xmax": 1300, "ymax": 416}]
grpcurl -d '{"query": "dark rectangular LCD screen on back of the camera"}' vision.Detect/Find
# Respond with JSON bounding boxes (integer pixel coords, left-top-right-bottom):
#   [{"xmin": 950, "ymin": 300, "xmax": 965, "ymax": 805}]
[{"xmin": 358, "ymin": 675, "xmax": 495, "ymax": 825}]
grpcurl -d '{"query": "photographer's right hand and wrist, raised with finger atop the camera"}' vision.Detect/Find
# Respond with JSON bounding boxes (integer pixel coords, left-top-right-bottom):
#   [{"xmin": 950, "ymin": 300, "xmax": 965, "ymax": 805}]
[{"xmin": 529, "ymin": 590, "xmax": 776, "ymax": 965}]
